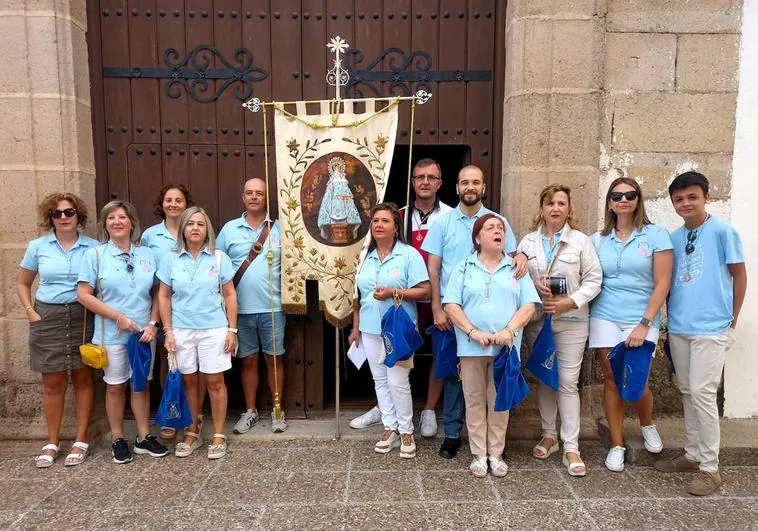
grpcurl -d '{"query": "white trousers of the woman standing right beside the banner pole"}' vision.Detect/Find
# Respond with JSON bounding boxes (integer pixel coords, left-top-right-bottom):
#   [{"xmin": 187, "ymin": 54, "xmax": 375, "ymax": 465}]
[{"xmin": 361, "ymin": 332, "xmax": 413, "ymax": 433}]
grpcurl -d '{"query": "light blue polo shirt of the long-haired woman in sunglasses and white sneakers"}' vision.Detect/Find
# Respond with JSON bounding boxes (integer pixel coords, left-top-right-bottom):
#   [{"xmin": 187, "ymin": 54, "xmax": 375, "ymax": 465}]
[{"xmin": 590, "ymin": 224, "xmax": 671, "ymax": 326}]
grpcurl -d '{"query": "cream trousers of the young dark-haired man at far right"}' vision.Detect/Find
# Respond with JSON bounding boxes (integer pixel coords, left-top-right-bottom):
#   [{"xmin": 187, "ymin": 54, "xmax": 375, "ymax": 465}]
[{"xmin": 669, "ymin": 329, "xmax": 733, "ymax": 472}]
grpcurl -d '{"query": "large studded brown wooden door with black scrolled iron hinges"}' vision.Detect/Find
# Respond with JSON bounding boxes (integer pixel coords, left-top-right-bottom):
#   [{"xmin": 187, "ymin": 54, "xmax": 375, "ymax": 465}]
[{"xmin": 87, "ymin": 0, "xmax": 505, "ymax": 416}]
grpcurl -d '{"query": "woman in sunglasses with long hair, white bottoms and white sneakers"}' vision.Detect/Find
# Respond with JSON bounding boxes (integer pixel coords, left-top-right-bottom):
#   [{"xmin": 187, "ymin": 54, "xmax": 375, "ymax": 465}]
[{"xmin": 589, "ymin": 177, "xmax": 673, "ymax": 472}]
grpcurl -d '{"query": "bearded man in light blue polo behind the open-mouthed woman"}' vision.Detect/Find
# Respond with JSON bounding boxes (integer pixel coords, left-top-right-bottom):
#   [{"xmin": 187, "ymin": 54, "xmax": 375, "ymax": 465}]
[{"xmin": 421, "ymin": 166, "xmax": 527, "ymax": 459}]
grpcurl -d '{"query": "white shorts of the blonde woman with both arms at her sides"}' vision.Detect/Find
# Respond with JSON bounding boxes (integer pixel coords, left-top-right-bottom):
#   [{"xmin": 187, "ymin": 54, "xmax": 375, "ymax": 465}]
[{"xmin": 174, "ymin": 326, "xmax": 232, "ymax": 374}]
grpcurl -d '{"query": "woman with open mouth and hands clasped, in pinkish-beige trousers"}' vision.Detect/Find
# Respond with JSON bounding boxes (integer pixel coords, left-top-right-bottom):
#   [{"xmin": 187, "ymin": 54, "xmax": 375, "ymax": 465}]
[{"xmin": 442, "ymin": 213, "xmax": 540, "ymax": 477}]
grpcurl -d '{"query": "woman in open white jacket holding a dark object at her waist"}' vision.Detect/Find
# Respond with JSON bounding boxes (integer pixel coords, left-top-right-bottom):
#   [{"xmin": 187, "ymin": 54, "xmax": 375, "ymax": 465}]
[{"xmin": 518, "ymin": 184, "xmax": 603, "ymax": 476}]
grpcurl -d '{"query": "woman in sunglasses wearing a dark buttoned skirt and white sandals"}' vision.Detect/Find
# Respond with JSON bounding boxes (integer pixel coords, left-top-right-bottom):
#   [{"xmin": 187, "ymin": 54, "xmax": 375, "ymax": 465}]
[{"xmin": 16, "ymin": 193, "xmax": 97, "ymax": 468}]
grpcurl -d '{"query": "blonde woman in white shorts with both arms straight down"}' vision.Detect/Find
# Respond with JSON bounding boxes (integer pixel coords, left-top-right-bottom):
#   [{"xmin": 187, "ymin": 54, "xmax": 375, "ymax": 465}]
[{"xmin": 158, "ymin": 206, "xmax": 237, "ymax": 459}]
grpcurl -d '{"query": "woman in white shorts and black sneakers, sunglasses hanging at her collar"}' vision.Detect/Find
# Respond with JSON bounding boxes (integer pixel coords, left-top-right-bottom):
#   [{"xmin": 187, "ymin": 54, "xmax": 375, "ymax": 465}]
[{"xmin": 78, "ymin": 201, "xmax": 168, "ymax": 464}]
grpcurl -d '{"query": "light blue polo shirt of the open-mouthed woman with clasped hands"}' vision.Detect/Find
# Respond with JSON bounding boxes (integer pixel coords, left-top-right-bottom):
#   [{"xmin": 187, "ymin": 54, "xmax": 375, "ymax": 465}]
[{"xmin": 442, "ymin": 254, "xmax": 541, "ymax": 357}]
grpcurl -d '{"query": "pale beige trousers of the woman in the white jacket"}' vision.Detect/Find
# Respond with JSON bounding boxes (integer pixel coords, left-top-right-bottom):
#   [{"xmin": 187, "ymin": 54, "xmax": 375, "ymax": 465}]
[{"xmin": 524, "ymin": 319, "xmax": 589, "ymax": 452}]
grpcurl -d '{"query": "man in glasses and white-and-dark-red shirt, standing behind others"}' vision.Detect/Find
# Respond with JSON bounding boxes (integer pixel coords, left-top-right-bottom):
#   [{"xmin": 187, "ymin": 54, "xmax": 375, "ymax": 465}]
[{"xmin": 350, "ymin": 159, "xmax": 451, "ymax": 437}]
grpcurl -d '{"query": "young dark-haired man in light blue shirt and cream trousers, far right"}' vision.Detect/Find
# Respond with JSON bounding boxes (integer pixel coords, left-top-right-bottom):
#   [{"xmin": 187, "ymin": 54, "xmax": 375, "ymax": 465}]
[{"xmin": 655, "ymin": 171, "xmax": 747, "ymax": 496}]
